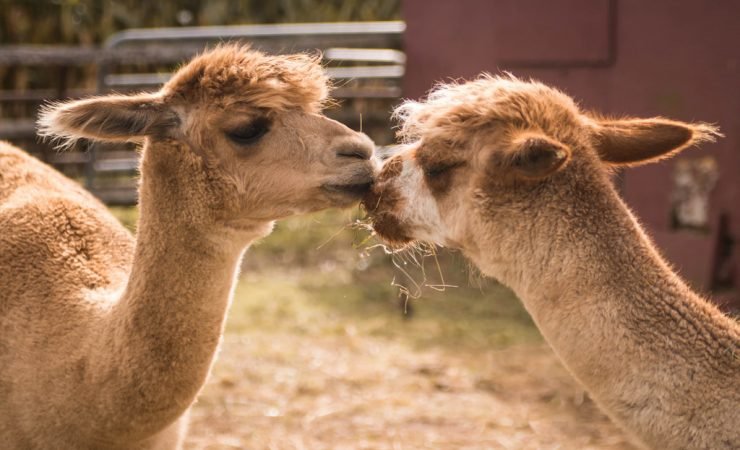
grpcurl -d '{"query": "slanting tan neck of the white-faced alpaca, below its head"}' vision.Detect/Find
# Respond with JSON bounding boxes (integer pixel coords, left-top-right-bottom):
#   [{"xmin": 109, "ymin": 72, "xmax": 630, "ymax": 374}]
[{"xmin": 474, "ymin": 170, "xmax": 740, "ymax": 448}]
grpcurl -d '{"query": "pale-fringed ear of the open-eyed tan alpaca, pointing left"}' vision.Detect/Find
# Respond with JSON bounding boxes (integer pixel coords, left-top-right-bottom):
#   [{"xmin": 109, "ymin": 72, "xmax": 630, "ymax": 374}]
[{"xmin": 38, "ymin": 94, "xmax": 178, "ymax": 147}]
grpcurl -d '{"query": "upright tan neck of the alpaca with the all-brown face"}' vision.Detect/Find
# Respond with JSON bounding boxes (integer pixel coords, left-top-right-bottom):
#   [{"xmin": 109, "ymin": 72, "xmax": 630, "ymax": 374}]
[{"xmin": 88, "ymin": 142, "xmax": 270, "ymax": 440}]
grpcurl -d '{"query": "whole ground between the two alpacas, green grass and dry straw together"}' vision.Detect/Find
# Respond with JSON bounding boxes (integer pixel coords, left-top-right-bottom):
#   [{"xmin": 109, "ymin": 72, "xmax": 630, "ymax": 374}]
[{"xmin": 181, "ymin": 265, "xmax": 634, "ymax": 450}]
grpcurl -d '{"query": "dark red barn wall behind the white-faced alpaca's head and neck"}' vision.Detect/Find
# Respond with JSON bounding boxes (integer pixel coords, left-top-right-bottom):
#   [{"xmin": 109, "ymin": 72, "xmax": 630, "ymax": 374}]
[{"xmin": 403, "ymin": 0, "xmax": 740, "ymax": 304}]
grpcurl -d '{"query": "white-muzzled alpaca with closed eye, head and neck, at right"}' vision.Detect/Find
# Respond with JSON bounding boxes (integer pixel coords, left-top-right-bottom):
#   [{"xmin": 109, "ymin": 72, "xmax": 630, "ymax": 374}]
[{"xmin": 363, "ymin": 75, "xmax": 740, "ymax": 450}]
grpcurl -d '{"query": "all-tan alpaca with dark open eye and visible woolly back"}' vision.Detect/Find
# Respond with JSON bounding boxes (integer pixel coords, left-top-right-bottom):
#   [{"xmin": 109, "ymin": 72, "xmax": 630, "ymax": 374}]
[{"xmin": 0, "ymin": 45, "xmax": 376, "ymax": 449}]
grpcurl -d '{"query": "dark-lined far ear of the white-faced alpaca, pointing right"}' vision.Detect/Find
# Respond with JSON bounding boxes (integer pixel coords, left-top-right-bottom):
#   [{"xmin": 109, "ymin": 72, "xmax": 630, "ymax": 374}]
[{"xmin": 593, "ymin": 118, "xmax": 722, "ymax": 165}]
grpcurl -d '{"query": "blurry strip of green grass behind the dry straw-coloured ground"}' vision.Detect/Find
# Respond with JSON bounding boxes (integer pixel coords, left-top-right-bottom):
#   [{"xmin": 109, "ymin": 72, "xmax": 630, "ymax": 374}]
[{"xmin": 227, "ymin": 254, "xmax": 541, "ymax": 351}]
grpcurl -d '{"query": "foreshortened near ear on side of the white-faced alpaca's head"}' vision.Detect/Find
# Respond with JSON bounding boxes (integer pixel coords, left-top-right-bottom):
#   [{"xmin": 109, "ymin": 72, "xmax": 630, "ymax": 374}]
[{"xmin": 506, "ymin": 136, "xmax": 570, "ymax": 179}]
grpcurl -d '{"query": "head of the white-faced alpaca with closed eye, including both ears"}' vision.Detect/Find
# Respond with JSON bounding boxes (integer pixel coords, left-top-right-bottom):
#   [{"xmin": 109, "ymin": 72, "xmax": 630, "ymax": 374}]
[{"xmin": 363, "ymin": 75, "xmax": 717, "ymax": 262}]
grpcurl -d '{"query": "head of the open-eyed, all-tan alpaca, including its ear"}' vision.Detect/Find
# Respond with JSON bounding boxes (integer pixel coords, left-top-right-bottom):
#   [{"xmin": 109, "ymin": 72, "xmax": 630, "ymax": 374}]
[{"xmin": 39, "ymin": 45, "xmax": 375, "ymax": 229}]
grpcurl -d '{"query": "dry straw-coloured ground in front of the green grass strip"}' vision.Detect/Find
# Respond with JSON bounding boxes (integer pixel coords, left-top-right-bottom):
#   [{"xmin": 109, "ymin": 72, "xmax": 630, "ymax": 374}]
[{"xmin": 186, "ymin": 334, "xmax": 634, "ymax": 450}]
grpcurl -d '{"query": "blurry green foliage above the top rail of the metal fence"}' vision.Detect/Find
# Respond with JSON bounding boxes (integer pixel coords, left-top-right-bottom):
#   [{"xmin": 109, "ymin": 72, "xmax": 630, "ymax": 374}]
[{"xmin": 0, "ymin": 0, "xmax": 401, "ymax": 45}]
